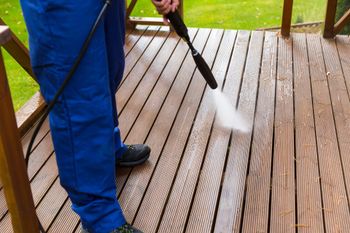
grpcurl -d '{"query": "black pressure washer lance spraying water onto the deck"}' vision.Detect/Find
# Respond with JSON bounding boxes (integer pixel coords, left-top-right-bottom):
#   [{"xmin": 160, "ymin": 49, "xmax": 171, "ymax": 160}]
[{"xmin": 165, "ymin": 10, "xmax": 218, "ymax": 89}]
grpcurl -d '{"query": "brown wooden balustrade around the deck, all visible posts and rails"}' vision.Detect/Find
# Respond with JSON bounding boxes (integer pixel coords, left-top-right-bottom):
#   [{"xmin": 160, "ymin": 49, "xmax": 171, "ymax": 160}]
[{"xmin": 0, "ymin": 0, "xmax": 350, "ymax": 233}]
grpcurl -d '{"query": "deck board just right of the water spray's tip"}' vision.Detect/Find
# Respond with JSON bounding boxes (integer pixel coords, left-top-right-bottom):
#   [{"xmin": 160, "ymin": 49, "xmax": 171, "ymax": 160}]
[{"xmin": 242, "ymin": 32, "xmax": 278, "ymax": 233}]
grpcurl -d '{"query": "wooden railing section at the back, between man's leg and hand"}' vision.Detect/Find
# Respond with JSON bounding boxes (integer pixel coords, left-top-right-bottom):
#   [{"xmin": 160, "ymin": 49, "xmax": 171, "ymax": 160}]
[{"xmin": 125, "ymin": 0, "xmax": 183, "ymax": 28}]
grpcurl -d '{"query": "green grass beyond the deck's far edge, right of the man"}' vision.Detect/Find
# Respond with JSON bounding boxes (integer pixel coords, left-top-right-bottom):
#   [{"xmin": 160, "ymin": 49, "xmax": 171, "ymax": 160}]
[{"xmin": 132, "ymin": 0, "xmax": 326, "ymax": 30}]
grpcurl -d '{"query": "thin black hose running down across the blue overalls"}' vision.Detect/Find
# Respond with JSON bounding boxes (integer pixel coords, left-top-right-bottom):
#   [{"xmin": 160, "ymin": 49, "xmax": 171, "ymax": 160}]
[{"xmin": 25, "ymin": 0, "xmax": 111, "ymax": 233}]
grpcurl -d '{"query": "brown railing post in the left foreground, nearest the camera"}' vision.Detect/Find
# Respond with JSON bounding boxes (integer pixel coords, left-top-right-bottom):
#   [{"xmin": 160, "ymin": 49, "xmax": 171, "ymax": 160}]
[{"xmin": 0, "ymin": 26, "xmax": 39, "ymax": 233}]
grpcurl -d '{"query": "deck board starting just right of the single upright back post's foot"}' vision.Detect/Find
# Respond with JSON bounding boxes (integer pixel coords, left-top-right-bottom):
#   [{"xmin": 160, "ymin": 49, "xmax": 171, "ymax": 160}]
[{"xmin": 293, "ymin": 34, "xmax": 324, "ymax": 232}]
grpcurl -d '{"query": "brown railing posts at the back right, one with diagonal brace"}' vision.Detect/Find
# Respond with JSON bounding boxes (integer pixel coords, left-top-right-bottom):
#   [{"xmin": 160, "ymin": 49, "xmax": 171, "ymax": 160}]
[{"xmin": 281, "ymin": 0, "xmax": 350, "ymax": 38}]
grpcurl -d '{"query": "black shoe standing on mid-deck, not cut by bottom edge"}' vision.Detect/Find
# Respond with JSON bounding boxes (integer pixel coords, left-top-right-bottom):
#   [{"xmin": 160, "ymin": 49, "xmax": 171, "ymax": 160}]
[{"xmin": 117, "ymin": 144, "xmax": 151, "ymax": 167}]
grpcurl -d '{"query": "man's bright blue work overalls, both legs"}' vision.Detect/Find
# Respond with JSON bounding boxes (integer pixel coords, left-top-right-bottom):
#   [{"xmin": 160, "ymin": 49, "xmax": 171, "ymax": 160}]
[{"xmin": 21, "ymin": 0, "xmax": 126, "ymax": 233}]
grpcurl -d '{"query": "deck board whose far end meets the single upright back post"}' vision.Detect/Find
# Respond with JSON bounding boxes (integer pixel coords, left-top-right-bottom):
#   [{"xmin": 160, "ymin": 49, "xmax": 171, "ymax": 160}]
[{"xmin": 270, "ymin": 31, "xmax": 296, "ymax": 233}]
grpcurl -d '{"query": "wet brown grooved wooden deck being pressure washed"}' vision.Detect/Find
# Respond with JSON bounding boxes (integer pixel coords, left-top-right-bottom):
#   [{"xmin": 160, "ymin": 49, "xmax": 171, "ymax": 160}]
[{"xmin": 0, "ymin": 26, "xmax": 350, "ymax": 233}]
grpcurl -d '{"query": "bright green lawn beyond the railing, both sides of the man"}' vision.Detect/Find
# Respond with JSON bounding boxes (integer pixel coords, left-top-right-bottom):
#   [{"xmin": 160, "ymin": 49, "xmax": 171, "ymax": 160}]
[{"xmin": 0, "ymin": 0, "xmax": 326, "ymax": 110}]
